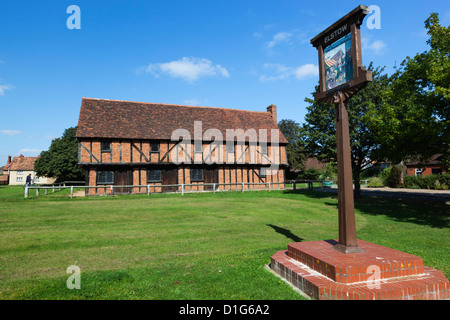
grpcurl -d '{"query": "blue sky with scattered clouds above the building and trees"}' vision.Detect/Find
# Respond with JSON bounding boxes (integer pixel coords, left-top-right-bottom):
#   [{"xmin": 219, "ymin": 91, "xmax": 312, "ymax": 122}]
[{"xmin": 0, "ymin": 0, "xmax": 450, "ymax": 165}]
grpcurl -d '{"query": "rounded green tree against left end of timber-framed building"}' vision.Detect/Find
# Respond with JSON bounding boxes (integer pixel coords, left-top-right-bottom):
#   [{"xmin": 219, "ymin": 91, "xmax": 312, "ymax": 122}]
[{"xmin": 34, "ymin": 127, "xmax": 84, "ymax": 181}]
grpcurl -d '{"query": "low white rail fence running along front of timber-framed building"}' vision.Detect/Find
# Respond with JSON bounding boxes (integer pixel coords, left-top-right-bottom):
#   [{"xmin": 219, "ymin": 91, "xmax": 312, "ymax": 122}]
[{"xmin": 24, "ymin": 181, "xmax": 320, "ymax": 199}]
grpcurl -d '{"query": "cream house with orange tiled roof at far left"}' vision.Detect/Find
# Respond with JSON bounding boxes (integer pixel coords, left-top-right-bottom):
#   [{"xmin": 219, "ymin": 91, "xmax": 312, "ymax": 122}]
[{"xmin": 3, "ymin": 154, "xmax": 55, "ymax": 185}]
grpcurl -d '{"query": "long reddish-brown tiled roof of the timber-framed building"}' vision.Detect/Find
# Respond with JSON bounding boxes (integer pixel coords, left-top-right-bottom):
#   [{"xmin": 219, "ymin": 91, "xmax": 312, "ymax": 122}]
[{"xmin": 76, "ymin": 98, "xmax": 287, "ymax": 143}]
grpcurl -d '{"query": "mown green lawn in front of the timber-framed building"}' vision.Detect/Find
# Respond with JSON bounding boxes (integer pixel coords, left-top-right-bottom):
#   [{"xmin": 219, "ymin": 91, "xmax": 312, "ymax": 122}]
[{"xmin": 0, "ymin": 187, "xmax": 450, "ymax": 300}]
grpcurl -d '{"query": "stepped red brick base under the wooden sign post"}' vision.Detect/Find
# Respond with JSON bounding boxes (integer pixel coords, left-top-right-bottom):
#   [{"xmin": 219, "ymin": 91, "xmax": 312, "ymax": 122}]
[{"xmin": 270, "ymin": 240, "xmax": 450, "ymax": 300}]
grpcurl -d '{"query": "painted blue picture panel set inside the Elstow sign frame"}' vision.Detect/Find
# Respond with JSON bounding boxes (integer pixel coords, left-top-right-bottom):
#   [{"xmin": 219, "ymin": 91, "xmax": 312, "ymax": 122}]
[{"xmin": 324, "ymin": 33, "xmax": 353, "ymax": 90}]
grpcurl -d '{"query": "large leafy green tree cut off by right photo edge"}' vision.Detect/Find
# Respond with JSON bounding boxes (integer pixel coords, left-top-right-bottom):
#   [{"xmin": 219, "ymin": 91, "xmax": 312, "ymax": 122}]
[{"xmin": 369, "ymin": 13, "xmax": 450, "ymax": 166}]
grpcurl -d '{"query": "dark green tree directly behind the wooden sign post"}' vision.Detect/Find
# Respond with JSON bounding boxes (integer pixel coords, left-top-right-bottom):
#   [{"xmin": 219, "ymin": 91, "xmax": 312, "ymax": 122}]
[{"xmin": 303, "ymin": 63, "xmax": 389, "ymax": 197}]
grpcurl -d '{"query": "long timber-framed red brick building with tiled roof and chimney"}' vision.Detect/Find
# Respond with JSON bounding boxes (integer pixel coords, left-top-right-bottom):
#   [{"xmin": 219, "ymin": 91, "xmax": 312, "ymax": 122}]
[{"xmin": 76, "ymin": 98, "xmax": 287, "ymax": 195}]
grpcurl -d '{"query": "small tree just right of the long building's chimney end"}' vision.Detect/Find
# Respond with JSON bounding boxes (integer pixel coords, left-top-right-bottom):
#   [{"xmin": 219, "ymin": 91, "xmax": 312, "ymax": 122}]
[{"xmin": 278, "ymin": 119, "xmax": 305, "ymax": 170}]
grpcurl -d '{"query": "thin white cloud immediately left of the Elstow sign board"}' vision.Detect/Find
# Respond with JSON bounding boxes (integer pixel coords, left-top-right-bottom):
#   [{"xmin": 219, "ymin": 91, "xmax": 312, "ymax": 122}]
[{"xmin": 259, "ymin": 63, "xmax": 319, "ymax": 82}]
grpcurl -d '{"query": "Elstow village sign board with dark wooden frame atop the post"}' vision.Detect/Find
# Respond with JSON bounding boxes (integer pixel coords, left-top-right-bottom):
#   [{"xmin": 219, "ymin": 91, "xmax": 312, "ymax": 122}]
[{"xmin": 311, "ymin": 5, "xmax": 372, "ymax": 102}]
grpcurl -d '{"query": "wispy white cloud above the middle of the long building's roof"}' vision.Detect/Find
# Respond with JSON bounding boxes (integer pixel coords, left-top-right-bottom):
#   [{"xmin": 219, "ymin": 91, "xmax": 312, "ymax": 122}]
[{"xmin": 136, "ymin": 57, "xmax": 230, "ymax": 82}]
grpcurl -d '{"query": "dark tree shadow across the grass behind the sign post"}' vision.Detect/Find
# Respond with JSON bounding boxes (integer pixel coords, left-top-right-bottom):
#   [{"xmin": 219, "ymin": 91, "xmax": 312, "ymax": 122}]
[{"xmin": 285, "ymin": 190, "xmax": 450, "ymax": 229}]
